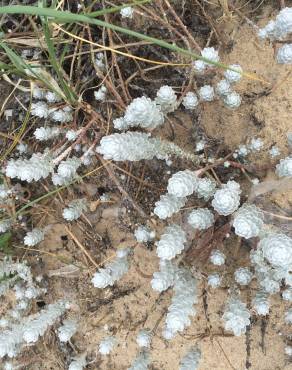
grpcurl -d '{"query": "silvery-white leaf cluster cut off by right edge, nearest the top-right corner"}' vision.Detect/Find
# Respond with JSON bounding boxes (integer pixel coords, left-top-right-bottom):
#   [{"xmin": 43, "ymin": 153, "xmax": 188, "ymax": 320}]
[{"xmin": 258, "ymin": 7, "xmax": 292, "ymax": 40}]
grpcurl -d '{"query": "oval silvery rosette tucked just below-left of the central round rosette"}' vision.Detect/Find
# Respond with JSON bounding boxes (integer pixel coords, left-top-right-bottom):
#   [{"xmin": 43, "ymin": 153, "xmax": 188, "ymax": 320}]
[{"xmin": 153, "ymin": 193, "xmax": 187, "ymax": 220}]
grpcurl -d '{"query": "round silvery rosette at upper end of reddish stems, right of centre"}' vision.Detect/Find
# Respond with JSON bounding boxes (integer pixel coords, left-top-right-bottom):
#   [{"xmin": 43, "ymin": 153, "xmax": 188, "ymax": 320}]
[{"xmin": 212, "ymin": 181, "xmax": 241, "ymax": 216}]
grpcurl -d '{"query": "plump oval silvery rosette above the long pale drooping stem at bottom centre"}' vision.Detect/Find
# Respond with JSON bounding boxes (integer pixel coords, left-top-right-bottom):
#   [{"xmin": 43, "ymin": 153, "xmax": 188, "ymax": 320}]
[{"xmin": 155, "ymin": 224, "xmax": 187, "ymax": 260}]
